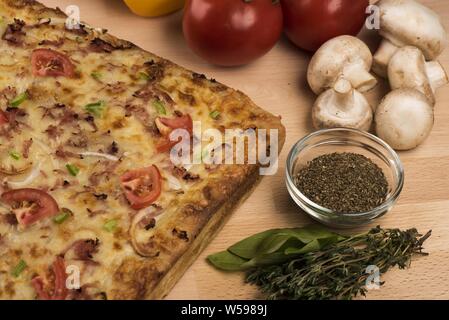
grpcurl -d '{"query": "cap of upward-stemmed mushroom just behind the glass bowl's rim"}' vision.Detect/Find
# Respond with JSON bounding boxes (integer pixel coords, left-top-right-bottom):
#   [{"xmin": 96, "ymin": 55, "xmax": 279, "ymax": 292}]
[{"xmin": 312, "ymin": 89, "xmax": 373, "ymax": 131}]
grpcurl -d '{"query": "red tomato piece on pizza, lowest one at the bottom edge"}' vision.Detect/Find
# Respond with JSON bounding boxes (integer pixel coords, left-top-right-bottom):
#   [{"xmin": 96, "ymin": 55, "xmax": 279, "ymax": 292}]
[{"xmin": 31, "ymin": 256, "xmax": 68, "ymax": 300}]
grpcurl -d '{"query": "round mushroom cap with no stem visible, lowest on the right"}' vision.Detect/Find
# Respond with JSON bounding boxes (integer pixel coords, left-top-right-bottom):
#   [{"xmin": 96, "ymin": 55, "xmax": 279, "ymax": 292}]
[{"xmin": 375, "ymin": 89, "xmax": 434, "ymax": 150}]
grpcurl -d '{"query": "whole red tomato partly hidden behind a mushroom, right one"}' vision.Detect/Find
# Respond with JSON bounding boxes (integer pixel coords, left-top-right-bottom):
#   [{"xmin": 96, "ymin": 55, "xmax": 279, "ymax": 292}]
[{"xmin": 281, "ymin": 0, "xmax": 369, "ymax": 51}]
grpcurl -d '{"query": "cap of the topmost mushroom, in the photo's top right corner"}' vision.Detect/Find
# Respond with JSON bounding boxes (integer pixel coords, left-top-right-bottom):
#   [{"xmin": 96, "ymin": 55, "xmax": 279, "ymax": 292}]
[{"xmin": 377, "ymin": 0, "xmax": 447, "ymax": 60}]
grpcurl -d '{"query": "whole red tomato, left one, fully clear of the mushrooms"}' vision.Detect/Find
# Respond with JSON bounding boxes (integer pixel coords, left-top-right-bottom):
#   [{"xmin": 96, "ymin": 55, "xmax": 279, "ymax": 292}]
[{"xmin": 183, "ymin": 0, "xmax": 282, "ymax": 66}]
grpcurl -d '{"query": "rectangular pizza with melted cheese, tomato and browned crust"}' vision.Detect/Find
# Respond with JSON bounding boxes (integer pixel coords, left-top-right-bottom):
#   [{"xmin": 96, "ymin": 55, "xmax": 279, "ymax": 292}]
[{"xmin": 0, "ymin": 0, "xmax": 285, "ymax": 300}]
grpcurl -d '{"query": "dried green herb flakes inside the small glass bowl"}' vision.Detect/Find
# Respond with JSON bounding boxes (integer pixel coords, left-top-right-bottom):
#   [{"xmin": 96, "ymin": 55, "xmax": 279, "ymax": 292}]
[{"xmin": 294, "ymin": 153, "xmax": 389, "ymax": 213}]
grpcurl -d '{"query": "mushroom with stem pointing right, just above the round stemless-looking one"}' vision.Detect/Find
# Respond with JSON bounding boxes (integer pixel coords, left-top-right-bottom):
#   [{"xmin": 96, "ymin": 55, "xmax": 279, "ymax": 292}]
[{"xmin": 388, "ymin": 46, "xmax": 448, "ymax": 105}]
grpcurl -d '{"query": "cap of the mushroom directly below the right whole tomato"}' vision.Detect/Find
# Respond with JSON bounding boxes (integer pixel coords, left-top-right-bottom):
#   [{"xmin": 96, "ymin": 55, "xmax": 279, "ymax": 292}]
[{"xmin": 307, "ymin": 35, "xmax": 373, "ymax": 95}]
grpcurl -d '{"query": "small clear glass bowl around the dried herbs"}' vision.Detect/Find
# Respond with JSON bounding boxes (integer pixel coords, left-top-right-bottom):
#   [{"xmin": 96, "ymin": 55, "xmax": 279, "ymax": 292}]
[{"xmin": 286, "ymin": 128, "xmax": 404, "ymax": 228}]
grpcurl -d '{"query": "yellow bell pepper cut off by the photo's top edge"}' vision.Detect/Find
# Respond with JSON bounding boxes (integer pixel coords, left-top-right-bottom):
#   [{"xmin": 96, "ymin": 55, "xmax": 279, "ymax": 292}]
[{"xmin": 124, "ymin": 0, "xmax": 185, "ymax": 17}]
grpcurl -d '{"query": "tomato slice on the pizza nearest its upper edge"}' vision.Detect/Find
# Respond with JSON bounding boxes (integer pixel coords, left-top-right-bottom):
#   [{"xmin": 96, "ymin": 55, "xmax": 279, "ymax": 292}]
[{"xmin": 31, "ymin": 49, "xmax": 75, "ymax": 78}]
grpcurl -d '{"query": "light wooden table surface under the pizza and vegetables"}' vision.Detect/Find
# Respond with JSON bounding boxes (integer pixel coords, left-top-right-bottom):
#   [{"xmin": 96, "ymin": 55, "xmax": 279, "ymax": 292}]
[{"xmin": 41, "ymin": 0, "xmax": 449, "ymax": 299}]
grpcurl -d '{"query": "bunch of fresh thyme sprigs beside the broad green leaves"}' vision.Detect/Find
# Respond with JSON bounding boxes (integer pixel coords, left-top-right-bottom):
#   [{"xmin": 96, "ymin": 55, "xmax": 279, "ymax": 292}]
[{"xmin": 247, "ymin": 227, "xmax": 431, "ymax": 300}]
